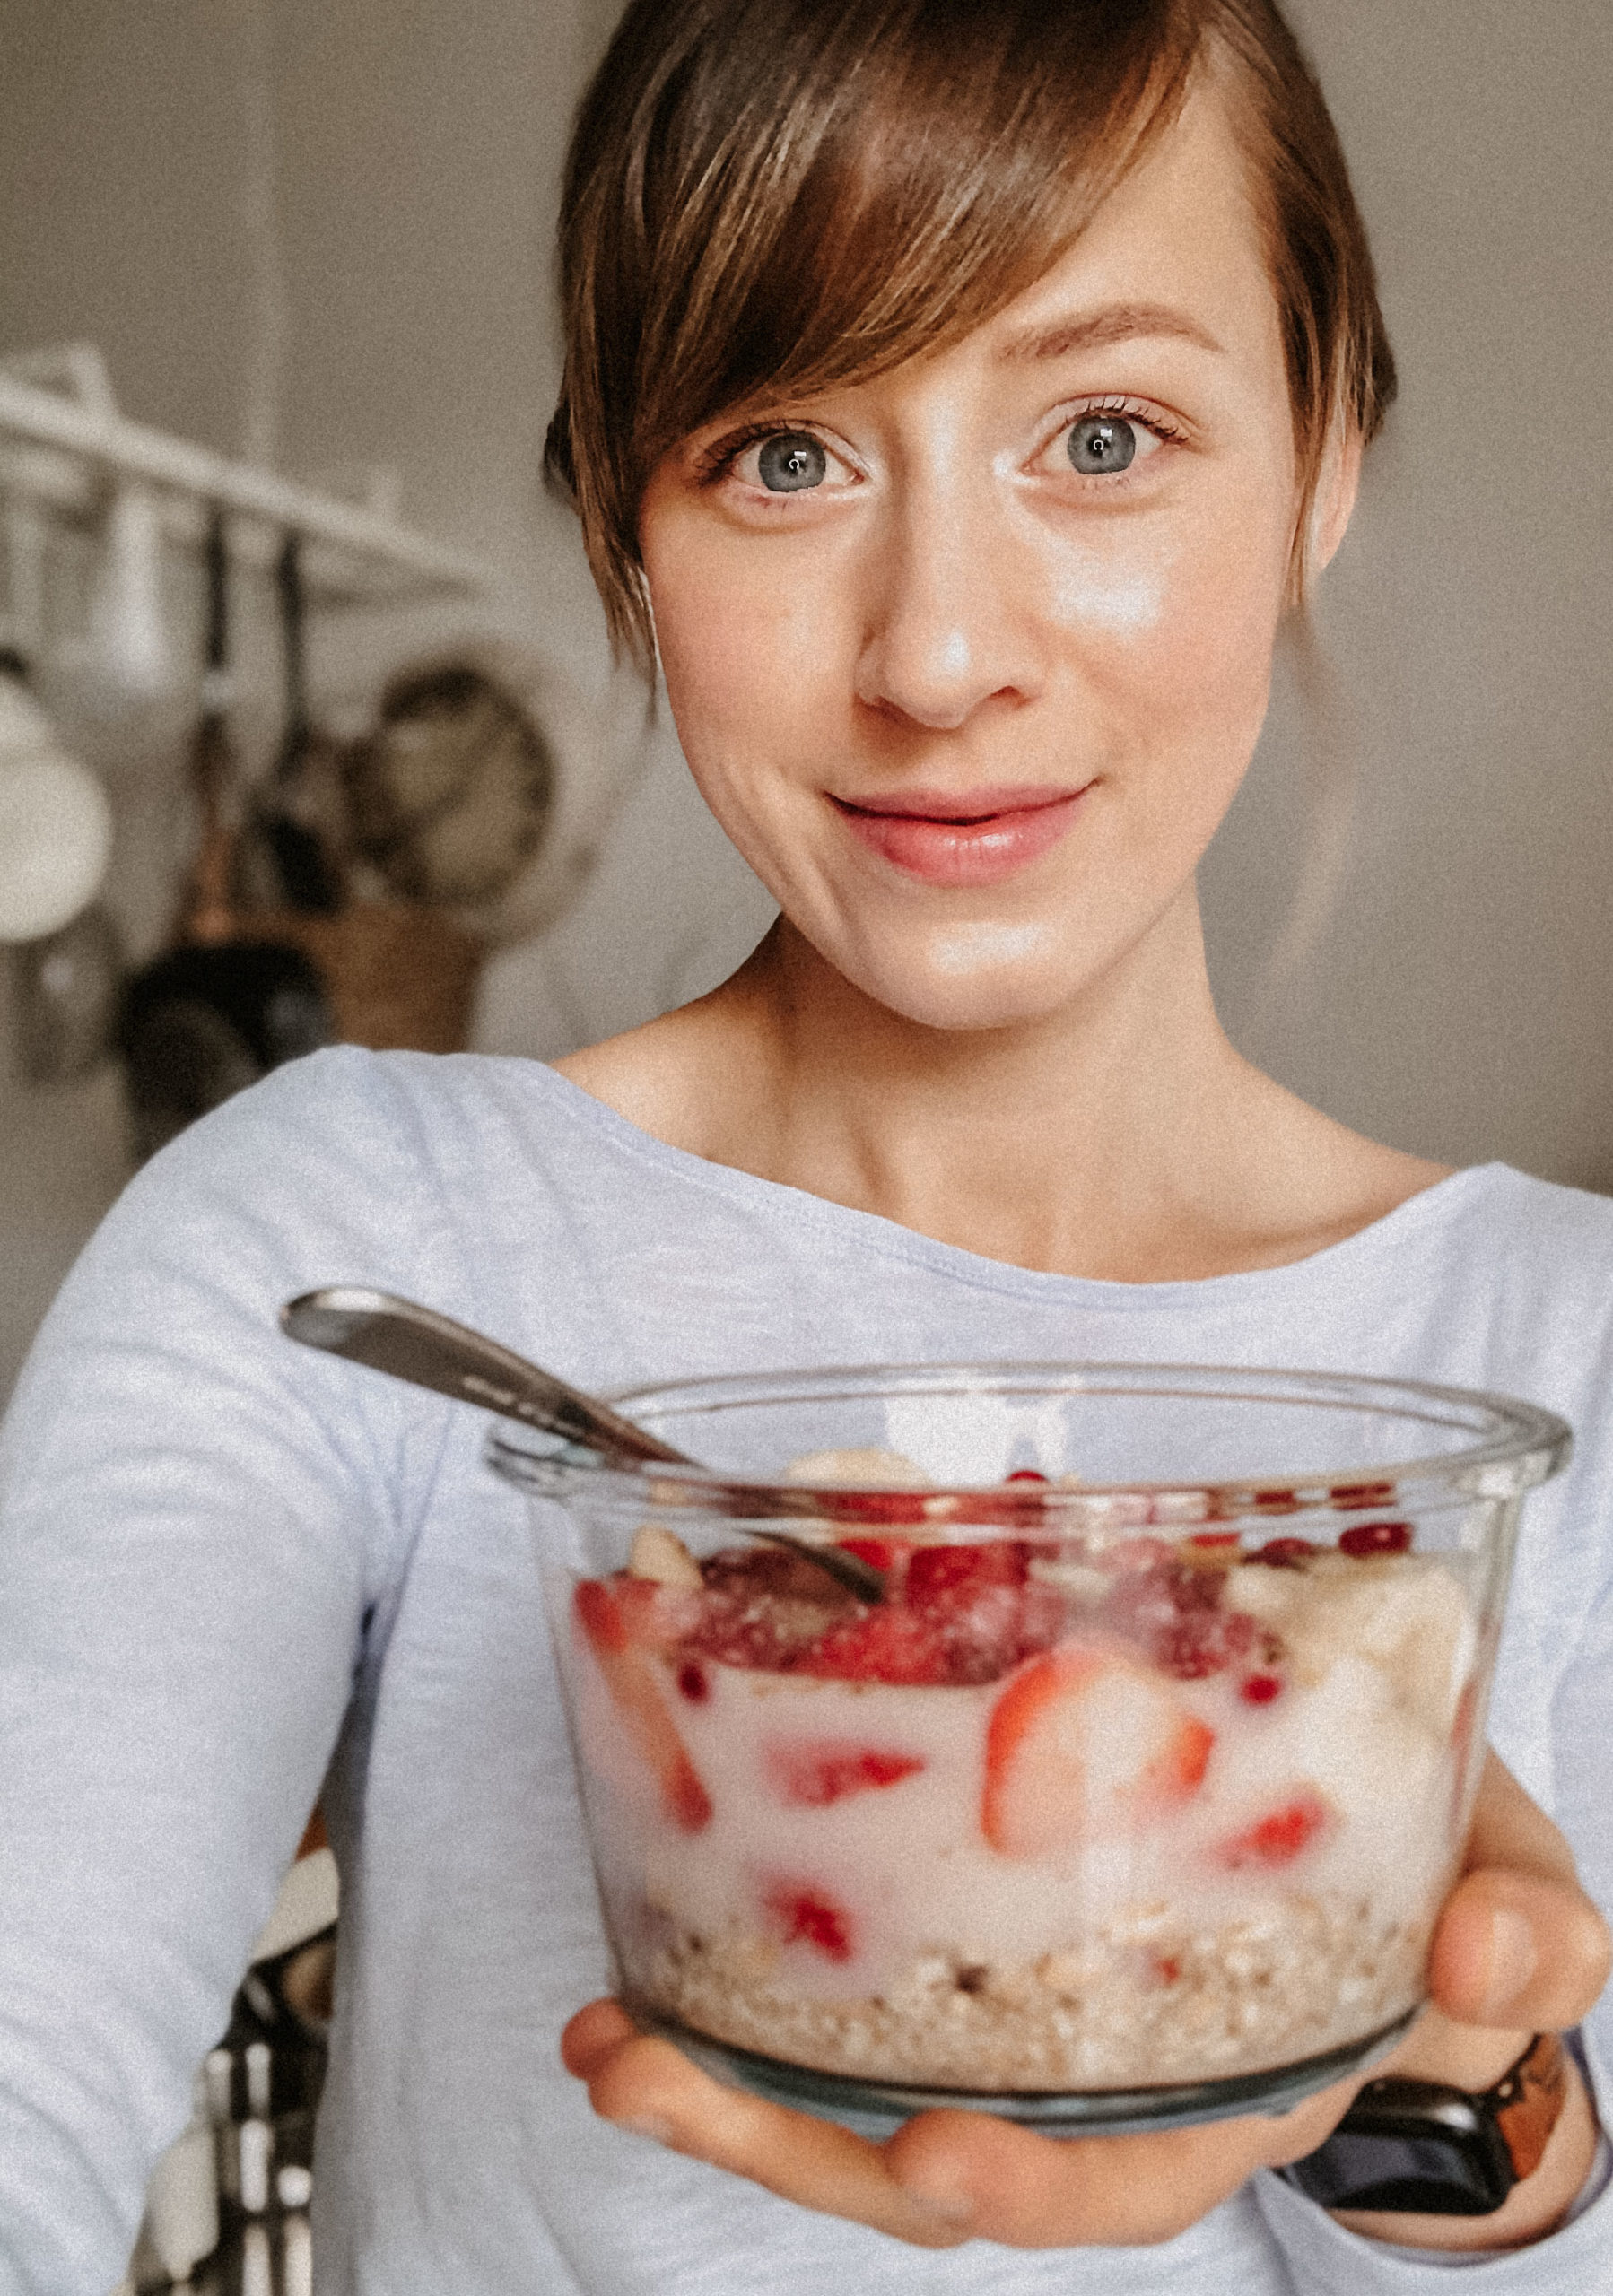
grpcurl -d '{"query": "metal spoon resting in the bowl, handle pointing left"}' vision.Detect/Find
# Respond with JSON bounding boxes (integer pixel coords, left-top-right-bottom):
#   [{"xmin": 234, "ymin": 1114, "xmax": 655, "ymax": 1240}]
[{"xmin": 280, "ymin": 1283, "xmax": 885, "ymax": 1603}]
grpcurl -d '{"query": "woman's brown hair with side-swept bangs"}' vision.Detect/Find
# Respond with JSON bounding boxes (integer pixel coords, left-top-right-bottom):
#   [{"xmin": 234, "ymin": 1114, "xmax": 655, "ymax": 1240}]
[{"xmin": 545, "ymin": 0, "xmax": 1395, "ymax": 665}]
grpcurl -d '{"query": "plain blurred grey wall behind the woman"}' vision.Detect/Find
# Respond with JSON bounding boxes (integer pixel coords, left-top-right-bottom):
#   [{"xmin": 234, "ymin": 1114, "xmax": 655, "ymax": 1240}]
[{"xmin": 0, "ymin": 0, "xmax": 1613, "ymax": 1394}]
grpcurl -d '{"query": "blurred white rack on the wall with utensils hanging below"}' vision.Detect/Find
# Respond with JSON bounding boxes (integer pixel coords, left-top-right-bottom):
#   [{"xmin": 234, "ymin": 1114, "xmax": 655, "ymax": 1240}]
[{"xmin": 0, "ymin": 344, "xmax": 496, "ymax": 604}]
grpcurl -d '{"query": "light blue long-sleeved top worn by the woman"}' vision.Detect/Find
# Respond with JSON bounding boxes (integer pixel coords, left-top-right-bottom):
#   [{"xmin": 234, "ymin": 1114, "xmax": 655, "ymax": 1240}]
[{"xmin": 0, "ymin": 1049, "xmax": 1613, "ymax": 2296}]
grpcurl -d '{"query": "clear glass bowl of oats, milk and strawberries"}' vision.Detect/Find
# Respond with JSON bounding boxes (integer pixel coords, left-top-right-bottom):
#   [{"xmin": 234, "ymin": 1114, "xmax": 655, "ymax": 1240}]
[{"xmin": 490, "ymin": 1364, "xmax": 1569, "ymax": 2135}]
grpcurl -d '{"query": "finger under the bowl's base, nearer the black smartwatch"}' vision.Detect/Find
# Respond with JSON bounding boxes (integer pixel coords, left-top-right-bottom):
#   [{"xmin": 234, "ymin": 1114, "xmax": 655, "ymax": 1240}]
[{"xmin": 885, "ymin": 2080, "xmax": 1360, "ymax": 2248}]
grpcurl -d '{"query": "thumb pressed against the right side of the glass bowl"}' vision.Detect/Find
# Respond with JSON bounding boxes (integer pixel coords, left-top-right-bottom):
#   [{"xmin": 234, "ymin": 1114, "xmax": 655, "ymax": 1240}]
[{"xmin": 1429, "ymin": 1754, "xmax": 1610, "ymax": 2032}]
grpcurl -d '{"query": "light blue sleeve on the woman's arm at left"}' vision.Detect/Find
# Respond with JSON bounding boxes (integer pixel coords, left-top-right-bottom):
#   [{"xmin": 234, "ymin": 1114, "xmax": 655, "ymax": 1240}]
[{"xmin": 0, "ymin": 1054, "xmax": 452, "ymax": 2296}]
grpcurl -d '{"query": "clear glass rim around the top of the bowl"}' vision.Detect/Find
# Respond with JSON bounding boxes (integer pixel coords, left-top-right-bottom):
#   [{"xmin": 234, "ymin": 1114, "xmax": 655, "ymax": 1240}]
[{"xmin": 484, "ymin": 1357, "xmax": 1574, "ymax": 1529}]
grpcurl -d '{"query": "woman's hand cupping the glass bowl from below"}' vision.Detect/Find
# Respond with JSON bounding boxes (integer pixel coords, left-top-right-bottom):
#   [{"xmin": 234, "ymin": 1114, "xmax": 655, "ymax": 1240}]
[{"xmin": 563, "ymin": 1754, "xmax": 1609, "ymax": 2248}]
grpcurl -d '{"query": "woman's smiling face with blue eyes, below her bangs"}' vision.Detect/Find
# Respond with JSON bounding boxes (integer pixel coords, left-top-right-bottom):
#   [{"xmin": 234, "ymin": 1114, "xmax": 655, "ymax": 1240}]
[{"xmin": 639, "ymin": 94, "xmax": 1347, "ymax": 1026}]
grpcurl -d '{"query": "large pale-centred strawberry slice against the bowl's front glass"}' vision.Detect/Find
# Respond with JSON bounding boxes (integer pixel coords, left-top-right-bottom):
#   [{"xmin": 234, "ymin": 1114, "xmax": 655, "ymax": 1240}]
[{"xmin": 981, "ymin": 1641, "xmax": 1216, "ymax": 1857}]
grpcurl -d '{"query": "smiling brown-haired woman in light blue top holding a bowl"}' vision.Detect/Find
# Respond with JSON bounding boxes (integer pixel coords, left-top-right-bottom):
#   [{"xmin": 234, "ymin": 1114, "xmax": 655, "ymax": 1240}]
[{"xmin": 0, "ymin": 0, "xmax": 1613, "ymax": 2296}]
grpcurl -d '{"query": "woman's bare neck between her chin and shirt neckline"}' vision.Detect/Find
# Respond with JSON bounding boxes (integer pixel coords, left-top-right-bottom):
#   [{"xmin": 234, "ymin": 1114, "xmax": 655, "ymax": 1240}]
[{"xmin": 689, "ymin": 889, "xmax": 1282, "ymax": 1274}]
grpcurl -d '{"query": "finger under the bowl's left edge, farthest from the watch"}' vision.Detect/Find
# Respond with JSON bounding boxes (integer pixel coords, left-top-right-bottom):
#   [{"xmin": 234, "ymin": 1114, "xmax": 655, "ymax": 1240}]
[{"xmin": 565, "ymin": 2002, "xmax": 970, "ymax": 2248}]
